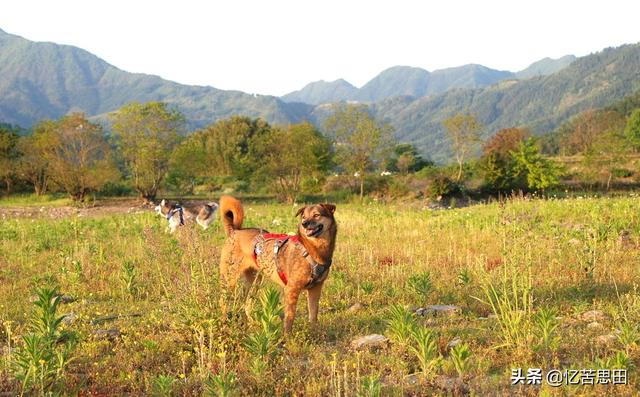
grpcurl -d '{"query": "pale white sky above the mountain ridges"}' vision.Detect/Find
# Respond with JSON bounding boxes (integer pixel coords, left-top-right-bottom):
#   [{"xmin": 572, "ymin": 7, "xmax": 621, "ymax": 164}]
[{"xmin": 0, "ymin": 0, "xmax": 640, "ymax": 95}]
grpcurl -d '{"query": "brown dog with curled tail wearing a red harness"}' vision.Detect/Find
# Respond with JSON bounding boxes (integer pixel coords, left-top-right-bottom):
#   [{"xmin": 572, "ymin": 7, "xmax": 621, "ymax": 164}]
[{"xmin": 220, "ymin": 196, "xmax": 338, "ymax": 332}]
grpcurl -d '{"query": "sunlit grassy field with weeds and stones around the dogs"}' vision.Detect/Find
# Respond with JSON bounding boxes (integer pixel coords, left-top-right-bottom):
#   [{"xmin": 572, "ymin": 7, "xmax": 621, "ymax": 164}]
[{"xmin": 0, "ymin": 197, "xmax": 640, "ymax": 396}]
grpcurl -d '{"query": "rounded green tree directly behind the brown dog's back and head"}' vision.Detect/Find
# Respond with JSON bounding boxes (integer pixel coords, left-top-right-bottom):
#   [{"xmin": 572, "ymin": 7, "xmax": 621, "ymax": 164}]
[{"xmin": 252, "ymin": 122, "xmax": 331, "ymax": 203}]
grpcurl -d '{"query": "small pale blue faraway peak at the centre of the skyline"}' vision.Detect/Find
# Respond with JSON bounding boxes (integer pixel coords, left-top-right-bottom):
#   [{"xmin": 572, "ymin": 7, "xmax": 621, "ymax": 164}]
[{"xmin": 280, "ymin": 79, "xmax": 358, "ymax": 105}]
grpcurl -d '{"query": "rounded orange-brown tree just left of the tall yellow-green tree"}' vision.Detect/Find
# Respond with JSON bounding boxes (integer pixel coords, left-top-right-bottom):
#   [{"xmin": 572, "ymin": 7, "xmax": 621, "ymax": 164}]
[{"xmin": 44, "ymin": 113, "xmax": 118, "ymax": 200}]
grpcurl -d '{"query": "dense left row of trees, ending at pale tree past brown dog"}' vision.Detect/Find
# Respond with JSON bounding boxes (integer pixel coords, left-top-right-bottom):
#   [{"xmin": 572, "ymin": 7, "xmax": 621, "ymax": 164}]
[{"xmin": 0, "ymin": 102, "xmax": 402, "ymax": 202}]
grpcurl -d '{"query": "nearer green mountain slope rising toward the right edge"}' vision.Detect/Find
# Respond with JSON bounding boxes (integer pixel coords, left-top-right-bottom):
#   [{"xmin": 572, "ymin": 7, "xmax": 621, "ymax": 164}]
[{"xmin": 376, "ymin": 44, "xmax": 640, "ymax": 161}]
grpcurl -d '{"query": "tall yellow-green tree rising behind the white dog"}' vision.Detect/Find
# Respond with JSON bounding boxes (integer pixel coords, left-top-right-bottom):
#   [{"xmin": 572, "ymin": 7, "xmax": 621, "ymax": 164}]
[{"xmin": 112, "ymin": 102, "xmax": 184, "ymax": 201}]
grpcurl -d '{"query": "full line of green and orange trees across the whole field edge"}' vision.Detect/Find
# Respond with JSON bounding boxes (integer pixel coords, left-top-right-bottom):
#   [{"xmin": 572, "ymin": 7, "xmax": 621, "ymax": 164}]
[{"xmin": 0, "ymin": 95, "xmax": 640, "ymax": 202}]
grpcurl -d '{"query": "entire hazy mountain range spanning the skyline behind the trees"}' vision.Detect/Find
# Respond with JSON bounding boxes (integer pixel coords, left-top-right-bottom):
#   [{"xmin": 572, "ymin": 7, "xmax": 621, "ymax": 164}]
[{"xmin": 0, "ymin": 30, "xmax": 640, "ymax": 161}]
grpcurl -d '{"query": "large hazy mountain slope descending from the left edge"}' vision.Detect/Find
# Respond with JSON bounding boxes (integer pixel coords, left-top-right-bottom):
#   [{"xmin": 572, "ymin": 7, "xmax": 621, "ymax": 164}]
[{"xmin": 0, "ymin": 30, "xmax": 310, "ymax": 127}]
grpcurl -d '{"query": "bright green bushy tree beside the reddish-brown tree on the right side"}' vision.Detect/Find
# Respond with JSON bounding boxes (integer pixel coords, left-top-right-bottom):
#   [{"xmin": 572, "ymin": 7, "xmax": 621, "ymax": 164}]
[{"xmin": 511, "ymin": 138, "xmax": 562, "ymax": 190}]
